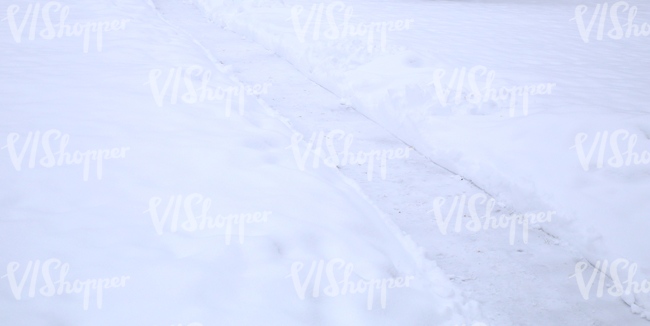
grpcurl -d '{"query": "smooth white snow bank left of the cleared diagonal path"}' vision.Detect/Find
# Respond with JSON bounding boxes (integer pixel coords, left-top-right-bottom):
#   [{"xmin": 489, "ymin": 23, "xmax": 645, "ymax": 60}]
[{"xmin": 0, "ymin": 1, "xmax": 479, "ymax": 326}]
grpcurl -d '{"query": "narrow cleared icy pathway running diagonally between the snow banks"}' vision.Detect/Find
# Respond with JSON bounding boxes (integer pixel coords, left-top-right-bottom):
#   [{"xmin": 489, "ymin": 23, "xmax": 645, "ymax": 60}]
[{"xmin": 149, "ymin": 1, "xmax": 647, "ymax": 325}]
